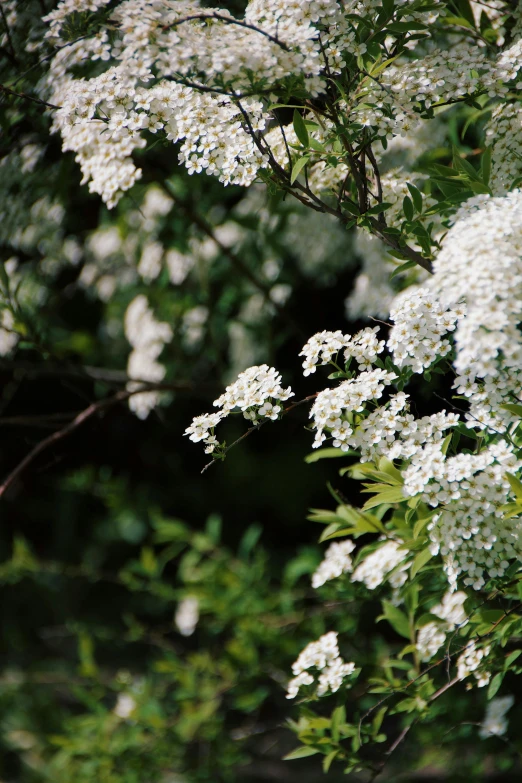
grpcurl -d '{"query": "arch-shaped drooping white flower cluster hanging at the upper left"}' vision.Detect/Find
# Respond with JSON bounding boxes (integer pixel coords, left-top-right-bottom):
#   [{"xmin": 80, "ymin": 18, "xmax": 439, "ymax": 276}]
[{"xmin": 49, "ymin": 64, "xmax": 265, "ymax": 207}]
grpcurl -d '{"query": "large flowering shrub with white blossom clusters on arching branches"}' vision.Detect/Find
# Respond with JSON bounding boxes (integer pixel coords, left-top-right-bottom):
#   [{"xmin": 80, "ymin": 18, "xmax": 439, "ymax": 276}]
[{"xmin": 0, "ymin": 0, "xmax": 522, "ymax": 780}]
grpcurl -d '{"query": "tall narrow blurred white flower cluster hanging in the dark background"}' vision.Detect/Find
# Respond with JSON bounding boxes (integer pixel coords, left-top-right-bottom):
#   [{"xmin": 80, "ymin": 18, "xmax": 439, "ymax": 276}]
[{"xmin": 124, "ymin": 294, "xmax": 173, "ymax": 419}]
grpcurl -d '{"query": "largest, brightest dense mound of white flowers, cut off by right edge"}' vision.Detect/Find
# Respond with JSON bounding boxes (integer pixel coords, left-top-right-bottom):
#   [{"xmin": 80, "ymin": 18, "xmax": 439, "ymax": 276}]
[{"xmin": 431, "ymin": 190, "xmax": 522, "ymax": 431}]
